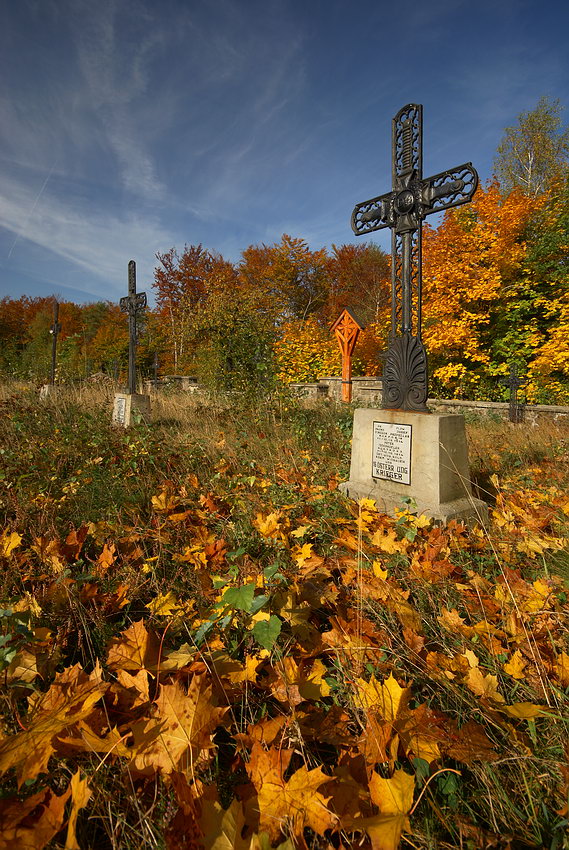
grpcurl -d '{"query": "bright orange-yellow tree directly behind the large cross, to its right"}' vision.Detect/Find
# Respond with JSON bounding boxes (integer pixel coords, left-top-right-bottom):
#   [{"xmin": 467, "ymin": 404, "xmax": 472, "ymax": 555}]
[{"xmin": 423, "ymin": 182, "xmax": 539, "ymax": 398}]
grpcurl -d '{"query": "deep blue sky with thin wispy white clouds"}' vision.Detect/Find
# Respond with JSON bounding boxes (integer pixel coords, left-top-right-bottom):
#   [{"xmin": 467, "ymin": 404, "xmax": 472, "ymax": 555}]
[{"xmin": 0, "ymin": 0, "xmax": 569, "ymax": 302}]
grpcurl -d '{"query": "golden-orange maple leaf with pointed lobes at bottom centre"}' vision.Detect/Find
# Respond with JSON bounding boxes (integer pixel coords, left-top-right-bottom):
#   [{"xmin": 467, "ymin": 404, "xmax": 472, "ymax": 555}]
[{"xmin": 248, "ymin": 744, "xmax": 338, "ymax": 841}]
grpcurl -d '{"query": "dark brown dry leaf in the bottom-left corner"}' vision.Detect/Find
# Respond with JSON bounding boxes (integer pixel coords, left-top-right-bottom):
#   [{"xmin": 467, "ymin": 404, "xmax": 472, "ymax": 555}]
[{"xmin": 0, "ymin": 788, "xmax": 71, "ymax": 850}]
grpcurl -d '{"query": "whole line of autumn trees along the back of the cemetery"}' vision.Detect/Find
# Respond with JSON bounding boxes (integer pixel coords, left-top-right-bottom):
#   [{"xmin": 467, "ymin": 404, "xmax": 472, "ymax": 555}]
[{"xmin": 0, "ymin": 98, "xmax": 569, "ymax": 403}]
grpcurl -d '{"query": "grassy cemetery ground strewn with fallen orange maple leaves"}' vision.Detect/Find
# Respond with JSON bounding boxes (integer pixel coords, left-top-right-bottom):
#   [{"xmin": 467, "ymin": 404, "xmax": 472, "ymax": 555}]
[{"xmin": 0, "ymin": 385, "xmax": 569, "ymax": 850}]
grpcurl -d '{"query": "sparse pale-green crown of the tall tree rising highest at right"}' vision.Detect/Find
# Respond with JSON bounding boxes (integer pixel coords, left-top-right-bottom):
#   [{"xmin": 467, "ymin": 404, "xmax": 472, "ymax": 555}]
[{"xmin": 495, "ymin": 97, "xmax": 569, "ymax": 198}]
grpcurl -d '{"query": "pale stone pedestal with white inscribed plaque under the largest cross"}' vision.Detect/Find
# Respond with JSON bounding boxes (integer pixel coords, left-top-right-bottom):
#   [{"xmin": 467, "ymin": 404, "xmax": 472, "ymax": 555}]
[{"xmin": 340, "ymin": 408, "xmax": 488, "ymax": 522}]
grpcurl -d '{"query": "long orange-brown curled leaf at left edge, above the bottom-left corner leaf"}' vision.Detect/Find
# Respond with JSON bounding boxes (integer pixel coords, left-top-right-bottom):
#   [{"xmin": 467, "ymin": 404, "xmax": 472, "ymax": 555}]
[{"xmin": 0, "ymin": 664, "xmax": 109, "ymax": 787}]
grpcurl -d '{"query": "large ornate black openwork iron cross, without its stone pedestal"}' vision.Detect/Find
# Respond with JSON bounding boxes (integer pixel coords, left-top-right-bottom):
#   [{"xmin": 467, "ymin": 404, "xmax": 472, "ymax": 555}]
[{"xmin": 352, "ymin": 103, "xmax": 478, "ymax": 412}]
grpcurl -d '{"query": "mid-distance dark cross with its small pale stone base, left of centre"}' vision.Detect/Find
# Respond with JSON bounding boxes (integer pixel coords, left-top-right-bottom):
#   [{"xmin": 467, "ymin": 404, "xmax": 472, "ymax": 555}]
[{"xmin": 113, "ymin": 260, "xmax": 150, "ymax": 428}]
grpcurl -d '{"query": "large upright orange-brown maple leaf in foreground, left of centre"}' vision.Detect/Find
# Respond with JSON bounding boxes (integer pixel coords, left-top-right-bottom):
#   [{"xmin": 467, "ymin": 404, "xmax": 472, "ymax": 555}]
[{"xmin": 131, "ymin": 675, "xmax": 227, "ymax": 775}]
